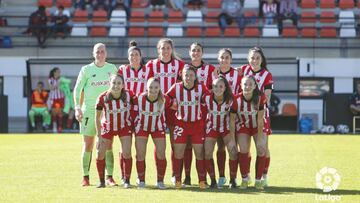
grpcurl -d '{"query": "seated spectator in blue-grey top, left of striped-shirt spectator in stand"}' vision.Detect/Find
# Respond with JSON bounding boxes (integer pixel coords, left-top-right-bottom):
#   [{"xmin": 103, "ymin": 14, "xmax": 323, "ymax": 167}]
[{"xmin": 219, "ymin": 0, "xmax": 245, "ymax": 29}]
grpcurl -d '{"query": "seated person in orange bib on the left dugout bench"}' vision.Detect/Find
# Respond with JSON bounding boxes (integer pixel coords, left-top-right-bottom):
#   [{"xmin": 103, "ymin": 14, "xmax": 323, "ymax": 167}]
[{"xmin": 29, "ymin": 81, "xmax": 51, "ymax": 131}]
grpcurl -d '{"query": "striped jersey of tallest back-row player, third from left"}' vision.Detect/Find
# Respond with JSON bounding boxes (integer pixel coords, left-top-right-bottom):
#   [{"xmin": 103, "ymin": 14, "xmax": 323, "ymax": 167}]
[{"xmin": 146, "ymin": 59, "xmax": 184, "ymax": 93}]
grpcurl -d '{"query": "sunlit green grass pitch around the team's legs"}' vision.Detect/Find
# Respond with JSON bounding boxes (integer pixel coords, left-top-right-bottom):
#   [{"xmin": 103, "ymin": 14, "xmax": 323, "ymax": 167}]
[{"xmin": 0, "ymin": 134, "xmax": 360, "ymax": 203}]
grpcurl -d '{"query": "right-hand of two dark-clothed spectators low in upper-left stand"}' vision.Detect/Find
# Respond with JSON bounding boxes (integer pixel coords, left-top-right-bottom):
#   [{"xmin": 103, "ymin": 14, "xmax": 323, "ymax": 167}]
[{"xmin": 51, "ymin": 5, "xmax": 70, "ymax": 38}]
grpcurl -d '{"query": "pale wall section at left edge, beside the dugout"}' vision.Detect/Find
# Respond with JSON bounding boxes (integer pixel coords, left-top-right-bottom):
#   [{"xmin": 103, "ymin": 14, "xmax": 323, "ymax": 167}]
[{"xmin": 0, "ymin": 57, "xmax": 27, "ymax": 117}]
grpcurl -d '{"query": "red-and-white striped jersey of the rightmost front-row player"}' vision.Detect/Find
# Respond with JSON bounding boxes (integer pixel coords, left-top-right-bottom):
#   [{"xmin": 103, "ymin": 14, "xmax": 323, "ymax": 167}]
[{"xmin": 231, "ymin": 93, "xmax": 266, "ymax": 128}]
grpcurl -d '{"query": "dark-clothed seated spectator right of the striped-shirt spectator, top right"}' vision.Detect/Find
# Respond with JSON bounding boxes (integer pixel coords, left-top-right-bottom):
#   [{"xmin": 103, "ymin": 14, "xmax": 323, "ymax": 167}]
[{"xmin": 278, "ymin": 0, "xmax": 298, "ymax": 34}]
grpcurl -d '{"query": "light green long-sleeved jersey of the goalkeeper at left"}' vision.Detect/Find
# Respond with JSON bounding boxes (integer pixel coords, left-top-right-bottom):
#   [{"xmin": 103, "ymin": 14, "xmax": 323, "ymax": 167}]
[{"xmin": 74, "ymin": 63, "xmax": 118, "ymax": 111}]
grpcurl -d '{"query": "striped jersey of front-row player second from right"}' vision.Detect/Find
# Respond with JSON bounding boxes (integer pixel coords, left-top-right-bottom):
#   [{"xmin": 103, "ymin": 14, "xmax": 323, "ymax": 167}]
[{"xmin": 203, "ymin": 94, "xmax": 233, "ymax": 133}]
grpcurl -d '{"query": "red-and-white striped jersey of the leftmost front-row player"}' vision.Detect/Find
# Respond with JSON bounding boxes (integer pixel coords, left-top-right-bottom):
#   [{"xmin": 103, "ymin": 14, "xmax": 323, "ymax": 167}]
[{"xmin": 96, "ymin": 90, "xmax": 135, "ymax": 134}]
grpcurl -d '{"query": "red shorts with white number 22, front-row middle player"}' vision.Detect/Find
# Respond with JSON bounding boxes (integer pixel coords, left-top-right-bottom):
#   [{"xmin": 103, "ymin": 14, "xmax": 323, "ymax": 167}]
[{"xmin": 173, "ymin": 119, "xmax": 205, "ymax": 144}]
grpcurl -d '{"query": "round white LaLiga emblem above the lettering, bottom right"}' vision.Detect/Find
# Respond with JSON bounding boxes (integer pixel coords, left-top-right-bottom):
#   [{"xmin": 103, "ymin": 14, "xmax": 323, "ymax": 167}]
[{"xmin": 316, "ymin": 167, "xmax": 341, "ymax": 192}]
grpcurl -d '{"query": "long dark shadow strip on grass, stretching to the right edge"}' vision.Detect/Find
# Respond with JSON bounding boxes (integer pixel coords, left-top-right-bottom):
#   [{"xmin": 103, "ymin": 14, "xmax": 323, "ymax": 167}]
[{"xmin": 134, "ymin": 186, "xmax": 360, "ymax": 195}]
